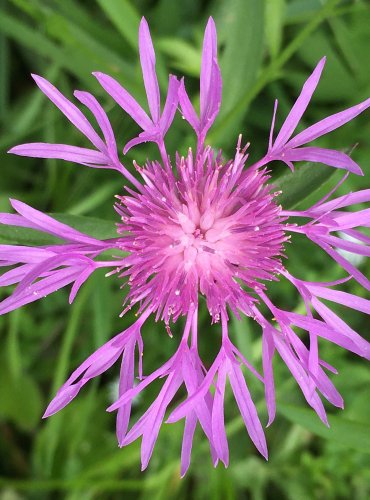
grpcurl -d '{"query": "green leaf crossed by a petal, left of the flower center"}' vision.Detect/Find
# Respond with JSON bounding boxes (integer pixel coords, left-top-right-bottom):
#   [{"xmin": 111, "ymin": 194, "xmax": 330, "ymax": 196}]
[{"xmin": 0, "ymin": 214, "xmax": 117, "ymax": 246}]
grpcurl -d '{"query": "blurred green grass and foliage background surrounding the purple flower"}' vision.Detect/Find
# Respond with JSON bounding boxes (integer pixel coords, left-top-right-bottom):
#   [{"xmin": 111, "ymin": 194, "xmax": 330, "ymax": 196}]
[{"xmin": 0, "ymin": 0, "xmax": 370, "ymax": 500}]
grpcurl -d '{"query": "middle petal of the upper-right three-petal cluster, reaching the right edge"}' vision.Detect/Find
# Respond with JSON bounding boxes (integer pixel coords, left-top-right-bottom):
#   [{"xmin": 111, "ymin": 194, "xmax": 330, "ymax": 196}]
[{"xmin": 286, "ymin": 98, "xmax": 370, "ymax": 148}]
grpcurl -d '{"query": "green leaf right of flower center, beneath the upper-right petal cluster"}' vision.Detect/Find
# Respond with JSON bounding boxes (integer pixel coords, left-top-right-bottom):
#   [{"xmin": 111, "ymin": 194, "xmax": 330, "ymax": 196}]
[{"xmin": 274, "ymin": 163, "xmax": 337, "ymax": 210}]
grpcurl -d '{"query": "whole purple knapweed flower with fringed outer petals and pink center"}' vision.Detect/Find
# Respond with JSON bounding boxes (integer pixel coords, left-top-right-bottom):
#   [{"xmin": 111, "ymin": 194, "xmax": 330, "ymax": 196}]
[{"xmin": 0, "ymin": 19, "xmax": 370, "ymax": 475}]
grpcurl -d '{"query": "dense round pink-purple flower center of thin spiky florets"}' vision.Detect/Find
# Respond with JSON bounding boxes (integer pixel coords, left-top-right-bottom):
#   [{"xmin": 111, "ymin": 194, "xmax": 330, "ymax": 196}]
[{"xmin": 117, "ymin": 146, "xmax": 285, "ymax": 321}]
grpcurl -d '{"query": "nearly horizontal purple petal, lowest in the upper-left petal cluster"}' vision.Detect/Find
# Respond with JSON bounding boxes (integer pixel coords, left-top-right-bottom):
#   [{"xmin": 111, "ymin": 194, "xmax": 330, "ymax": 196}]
[{"xmin": 8, "ymin": 142, "xmax": 108, "ymax": 165}]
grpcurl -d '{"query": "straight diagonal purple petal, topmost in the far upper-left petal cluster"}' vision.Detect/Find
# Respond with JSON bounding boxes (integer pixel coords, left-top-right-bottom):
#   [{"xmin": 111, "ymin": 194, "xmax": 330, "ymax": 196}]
[{"xmin": 32, "ymin": 75, "xmax": 104, "ymax": 150}]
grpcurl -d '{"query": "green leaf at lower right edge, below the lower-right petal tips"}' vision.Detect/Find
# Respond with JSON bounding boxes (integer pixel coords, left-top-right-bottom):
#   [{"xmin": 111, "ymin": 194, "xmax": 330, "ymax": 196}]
[{"xmin": 280, "ymin": 404, "xmax": 370, "ymax": 453}]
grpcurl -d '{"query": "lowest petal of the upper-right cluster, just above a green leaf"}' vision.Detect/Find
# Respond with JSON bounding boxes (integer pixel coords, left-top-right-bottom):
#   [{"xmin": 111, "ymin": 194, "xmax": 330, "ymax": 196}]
[{"xmin": 281, "ymin": 147, "xmax": 363, "ymax": 175}]
